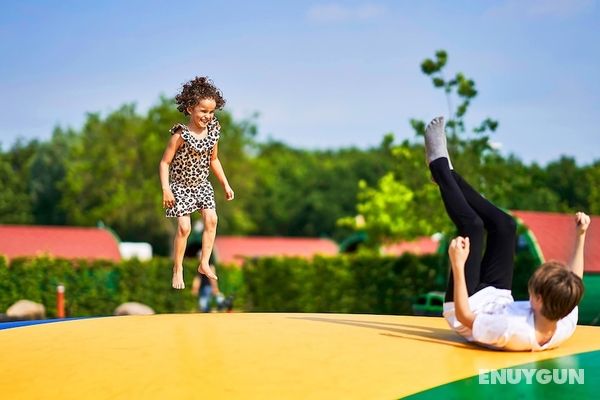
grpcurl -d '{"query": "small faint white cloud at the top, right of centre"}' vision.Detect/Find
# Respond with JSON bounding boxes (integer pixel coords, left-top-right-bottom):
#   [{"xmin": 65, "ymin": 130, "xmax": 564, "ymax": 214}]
[{"xmin": 307, "ymin": 3, "xmax": 385, "ymax": 22}]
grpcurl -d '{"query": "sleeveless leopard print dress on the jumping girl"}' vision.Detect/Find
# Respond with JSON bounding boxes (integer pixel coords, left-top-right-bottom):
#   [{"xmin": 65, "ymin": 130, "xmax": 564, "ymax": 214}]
[{"xmin": 166, "ymin": 118, "xmax": 221, "ymax": 217}]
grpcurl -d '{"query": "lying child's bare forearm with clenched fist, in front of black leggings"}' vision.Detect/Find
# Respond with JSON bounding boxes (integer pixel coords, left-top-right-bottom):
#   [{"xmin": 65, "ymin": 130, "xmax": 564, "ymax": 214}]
[{"xmin": 448, "ymin": 236, "xmax": 475, "ymax": 329}]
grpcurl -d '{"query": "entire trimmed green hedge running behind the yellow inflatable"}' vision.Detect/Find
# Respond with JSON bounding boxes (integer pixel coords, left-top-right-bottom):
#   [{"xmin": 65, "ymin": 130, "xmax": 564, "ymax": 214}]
[{"xmin": 0, "ymin": 250, "xmax": 535, "ymax": 317}]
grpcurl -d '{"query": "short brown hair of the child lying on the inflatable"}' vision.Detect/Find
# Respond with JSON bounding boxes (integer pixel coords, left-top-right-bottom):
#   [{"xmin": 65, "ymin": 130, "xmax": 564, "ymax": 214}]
[{"xmin": 528, "ymin": 261, "xmax": 583, "ymax": 321}]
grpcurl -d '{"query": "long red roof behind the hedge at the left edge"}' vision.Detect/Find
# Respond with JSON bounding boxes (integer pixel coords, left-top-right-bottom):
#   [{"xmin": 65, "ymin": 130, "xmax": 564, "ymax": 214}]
[{"xmin": 0, "ymin": 225, "xmax": 121, "ymax": 261}]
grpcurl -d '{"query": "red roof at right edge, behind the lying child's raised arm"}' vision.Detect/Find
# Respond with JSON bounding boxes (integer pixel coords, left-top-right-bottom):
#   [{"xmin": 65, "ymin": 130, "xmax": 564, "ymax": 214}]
[{"xmin": 512, "ymin": 211, "xmax": 600, "ymax": 272}]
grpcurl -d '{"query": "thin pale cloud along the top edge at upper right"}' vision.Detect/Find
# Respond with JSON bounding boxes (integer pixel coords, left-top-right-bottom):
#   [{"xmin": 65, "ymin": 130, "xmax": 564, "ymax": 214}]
[{"xmin": 487, "ymin": 0, "xmax": 596, "ymax": 18}]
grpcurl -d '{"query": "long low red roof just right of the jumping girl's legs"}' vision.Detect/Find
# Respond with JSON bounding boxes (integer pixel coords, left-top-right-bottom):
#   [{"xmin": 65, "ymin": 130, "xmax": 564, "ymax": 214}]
[{"xmin": 215, "ymin": 236, "xmax": 338, "ymax": 265}]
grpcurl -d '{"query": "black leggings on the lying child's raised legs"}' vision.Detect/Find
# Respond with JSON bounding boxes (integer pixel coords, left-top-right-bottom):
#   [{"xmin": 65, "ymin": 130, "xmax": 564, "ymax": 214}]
[{"xmin": 429, "ymin": 158, "xmax": 516, "ymax": 301}]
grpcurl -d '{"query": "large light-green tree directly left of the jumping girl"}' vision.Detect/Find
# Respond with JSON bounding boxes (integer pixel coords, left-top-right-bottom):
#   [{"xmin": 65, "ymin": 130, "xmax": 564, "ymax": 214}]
[{"xmin": 61, "ymin": 105, "xmax": 169, "ymax": 253}]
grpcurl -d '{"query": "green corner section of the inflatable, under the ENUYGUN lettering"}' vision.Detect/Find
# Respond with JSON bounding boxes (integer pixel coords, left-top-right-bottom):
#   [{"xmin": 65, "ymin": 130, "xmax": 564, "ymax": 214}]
[{"xmin": 405, "ymin": 350, "xmax": 600, "ymax": 400}]
